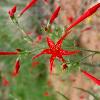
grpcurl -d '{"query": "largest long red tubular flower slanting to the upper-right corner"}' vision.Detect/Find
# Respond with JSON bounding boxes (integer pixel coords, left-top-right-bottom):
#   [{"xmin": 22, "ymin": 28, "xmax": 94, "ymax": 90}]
[{"xmin": 66, "ymin": 3, "xmax": 100, "ymax": 31}]
